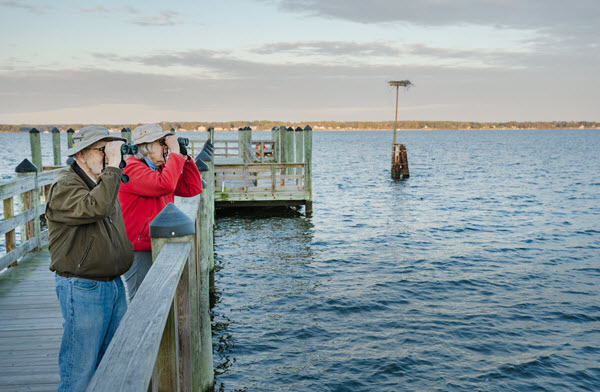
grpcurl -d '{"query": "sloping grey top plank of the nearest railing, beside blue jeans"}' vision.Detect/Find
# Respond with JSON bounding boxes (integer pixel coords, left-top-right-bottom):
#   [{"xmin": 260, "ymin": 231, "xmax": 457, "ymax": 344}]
[{"xmin": 88, "ymin": 242, "xmax": 191, "ymax": 391}]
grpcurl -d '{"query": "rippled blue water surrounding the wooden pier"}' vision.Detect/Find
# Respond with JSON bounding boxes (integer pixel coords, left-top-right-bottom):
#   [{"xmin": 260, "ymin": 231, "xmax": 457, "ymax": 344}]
[{"xmin": 0, "ymin": 130, "xmax": 600, "ymax": 391}]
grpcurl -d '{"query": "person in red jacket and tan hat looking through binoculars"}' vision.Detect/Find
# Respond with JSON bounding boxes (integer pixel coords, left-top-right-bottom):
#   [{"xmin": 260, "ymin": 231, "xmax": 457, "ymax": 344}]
[{"xmin": 119, "ymin": 124, "xmax": 202, "ymax": 302}]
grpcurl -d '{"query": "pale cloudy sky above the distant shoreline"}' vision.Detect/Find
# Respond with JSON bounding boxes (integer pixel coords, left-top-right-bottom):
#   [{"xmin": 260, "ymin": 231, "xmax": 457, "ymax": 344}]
[{"xmin": 0, "ymin": 0, "xmax": 600, "ymax": 124}]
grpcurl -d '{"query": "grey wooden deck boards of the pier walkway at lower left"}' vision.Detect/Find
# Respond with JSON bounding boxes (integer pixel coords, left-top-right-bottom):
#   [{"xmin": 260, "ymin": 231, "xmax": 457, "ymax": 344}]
[{"xmin": 0, "ymin": 247, "xmax": 62, "ymax": 391}]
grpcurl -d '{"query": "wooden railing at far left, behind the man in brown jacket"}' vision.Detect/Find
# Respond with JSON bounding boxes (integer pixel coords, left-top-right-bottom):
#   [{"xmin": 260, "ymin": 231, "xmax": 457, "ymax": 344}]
[{"xmin": 0, "ymin": 164, "xmax": 61, "ymax": 270}]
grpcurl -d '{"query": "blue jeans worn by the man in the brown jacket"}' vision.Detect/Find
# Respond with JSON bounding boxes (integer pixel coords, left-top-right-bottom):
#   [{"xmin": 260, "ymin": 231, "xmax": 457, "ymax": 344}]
[{"xmin": 55, "ymin": 275, "xmax": 127, "ymax": 392}]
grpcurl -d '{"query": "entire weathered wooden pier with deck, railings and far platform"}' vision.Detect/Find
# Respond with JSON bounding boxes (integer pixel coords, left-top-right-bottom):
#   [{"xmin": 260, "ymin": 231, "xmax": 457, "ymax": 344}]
[{"xmin": 0, "ymin": 127, "xmax": 312, "ymax": 392}]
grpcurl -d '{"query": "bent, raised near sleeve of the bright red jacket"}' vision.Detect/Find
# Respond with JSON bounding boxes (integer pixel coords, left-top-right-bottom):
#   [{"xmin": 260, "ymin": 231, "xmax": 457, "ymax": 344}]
[{"xmin": 121, "ymin": 154, "xmax": 186, "ymax": 197}]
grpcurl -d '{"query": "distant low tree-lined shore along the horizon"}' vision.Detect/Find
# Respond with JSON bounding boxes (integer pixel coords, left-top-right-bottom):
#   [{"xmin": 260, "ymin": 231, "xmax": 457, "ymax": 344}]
[{"xmin": 0, "ymin": 120, "xmax": 600, "ymax": 132}]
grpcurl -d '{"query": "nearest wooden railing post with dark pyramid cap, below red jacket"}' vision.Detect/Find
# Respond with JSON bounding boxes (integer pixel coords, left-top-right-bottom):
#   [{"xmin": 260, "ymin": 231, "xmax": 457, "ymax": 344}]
[{"xmin": 149, "ymin": 203, "xmax": 200, "ymax": 391}]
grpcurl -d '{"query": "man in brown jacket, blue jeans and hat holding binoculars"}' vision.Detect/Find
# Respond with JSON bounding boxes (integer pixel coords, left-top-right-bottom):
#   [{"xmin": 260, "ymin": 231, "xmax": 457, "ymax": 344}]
[{"xmin": 46, "ymin": 126, "xmax": 133, "ymax": 391}]
